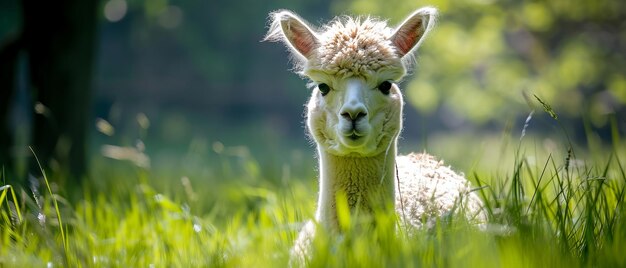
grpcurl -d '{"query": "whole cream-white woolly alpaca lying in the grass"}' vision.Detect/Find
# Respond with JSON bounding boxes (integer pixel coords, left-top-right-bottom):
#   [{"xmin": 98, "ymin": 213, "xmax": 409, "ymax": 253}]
[{"xmin": 265, "ymin": 8, "xmax": 482, "ymax": 256}]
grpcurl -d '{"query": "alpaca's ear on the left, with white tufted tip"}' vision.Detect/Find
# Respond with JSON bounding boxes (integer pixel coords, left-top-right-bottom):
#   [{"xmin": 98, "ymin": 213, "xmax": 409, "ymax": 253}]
[{"xmin": 263, "ymin": 10, "xmax": 319, "ymax": 59}]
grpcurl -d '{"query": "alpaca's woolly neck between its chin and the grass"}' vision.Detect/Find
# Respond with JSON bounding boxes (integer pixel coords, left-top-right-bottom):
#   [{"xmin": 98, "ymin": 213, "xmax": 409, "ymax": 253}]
[{"xmin": 316, "ymin": 141, "xmax": 396, "ymax": 229}]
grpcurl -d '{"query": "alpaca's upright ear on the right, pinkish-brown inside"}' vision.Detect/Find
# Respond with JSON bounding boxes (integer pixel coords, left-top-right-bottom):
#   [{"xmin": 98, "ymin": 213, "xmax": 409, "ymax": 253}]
[{"xmin": 391, "ymin": 7, "xmax": 437, "ymax": 57}]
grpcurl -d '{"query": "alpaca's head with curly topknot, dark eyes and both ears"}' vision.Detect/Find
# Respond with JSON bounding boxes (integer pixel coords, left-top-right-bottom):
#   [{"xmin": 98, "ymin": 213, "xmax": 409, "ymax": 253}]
[{"xmin": 265, "ymin": 8, "xmax": 436, "ymax": 157}]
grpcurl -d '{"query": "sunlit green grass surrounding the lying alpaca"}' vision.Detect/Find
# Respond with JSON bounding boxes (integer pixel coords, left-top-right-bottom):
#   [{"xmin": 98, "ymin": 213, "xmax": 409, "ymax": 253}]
[{"xmin": 0, "ymin": 112, "xmax": 626, "ymax": 267}]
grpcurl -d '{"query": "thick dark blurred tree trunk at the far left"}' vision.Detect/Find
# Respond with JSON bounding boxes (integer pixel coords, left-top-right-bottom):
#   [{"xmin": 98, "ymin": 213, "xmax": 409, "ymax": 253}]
[{"xmin": 0, "ymin": 0, "xmax": 98, "ymax": 181}]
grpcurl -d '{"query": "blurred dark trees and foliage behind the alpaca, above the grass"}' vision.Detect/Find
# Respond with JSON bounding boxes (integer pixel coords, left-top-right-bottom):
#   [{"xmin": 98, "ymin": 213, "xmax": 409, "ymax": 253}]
[{"xmin": 0, "ymin": 0, "xmax": 626, "ymax": 188}]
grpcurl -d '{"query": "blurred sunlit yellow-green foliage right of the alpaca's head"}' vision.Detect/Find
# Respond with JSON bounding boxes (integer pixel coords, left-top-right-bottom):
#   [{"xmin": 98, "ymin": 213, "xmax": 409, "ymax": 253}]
[{"xmin": 334, "ymin": 0, "xmax": 626, "ymax": 127}]
